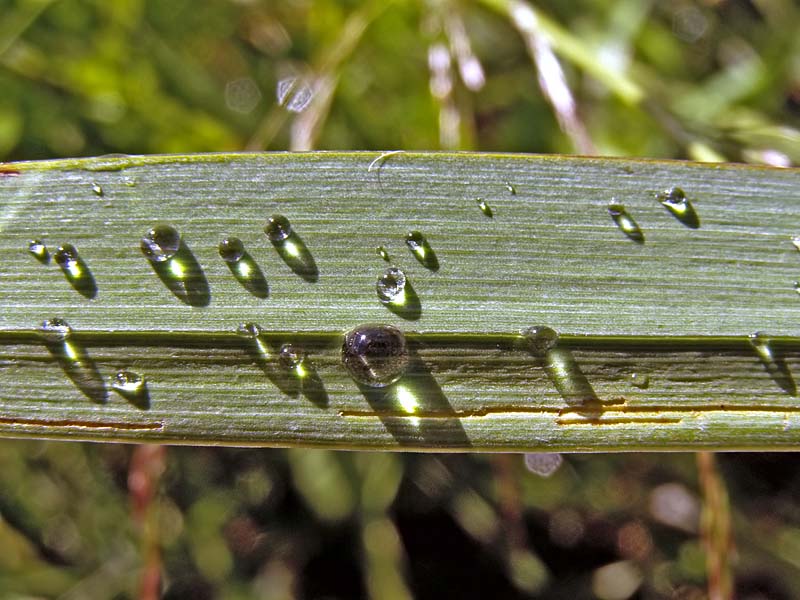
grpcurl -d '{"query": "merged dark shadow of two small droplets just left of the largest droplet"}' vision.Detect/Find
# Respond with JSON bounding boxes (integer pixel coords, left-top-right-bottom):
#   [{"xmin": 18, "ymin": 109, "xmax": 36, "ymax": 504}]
[{"xmin": 242, "ymin": 338, "xmax": 330, "ymax": 408}]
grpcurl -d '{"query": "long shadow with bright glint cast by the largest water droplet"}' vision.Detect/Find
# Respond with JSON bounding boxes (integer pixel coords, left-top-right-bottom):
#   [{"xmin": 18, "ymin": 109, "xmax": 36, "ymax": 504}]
[{"xmin": 358, "ymin": 347, "xmax": 472, "ymax": 448}]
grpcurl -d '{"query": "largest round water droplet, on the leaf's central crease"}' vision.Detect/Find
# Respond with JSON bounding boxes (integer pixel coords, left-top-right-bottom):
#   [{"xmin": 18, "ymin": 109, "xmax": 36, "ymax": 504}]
[{"xmin": 342, "ymin": 325, "xmax": 409, "ymax": 388}]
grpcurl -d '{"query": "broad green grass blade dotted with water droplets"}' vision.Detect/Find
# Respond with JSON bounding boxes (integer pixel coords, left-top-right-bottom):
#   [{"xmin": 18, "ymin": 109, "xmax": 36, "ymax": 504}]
[{"xmin": 0, "ymin": 152, "xmax": 800, "ymax": 452}]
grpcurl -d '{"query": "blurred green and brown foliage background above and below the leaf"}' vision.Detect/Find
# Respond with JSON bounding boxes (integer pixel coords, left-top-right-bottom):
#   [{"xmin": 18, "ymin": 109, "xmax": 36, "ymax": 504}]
[{"xmin": 0, "ymin": 0, "xmax": 800, "ymax": 600}]
